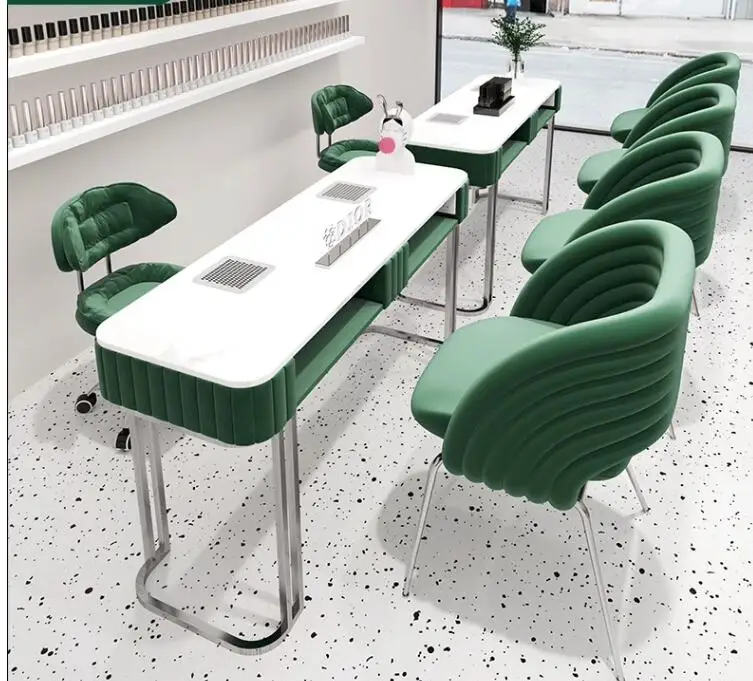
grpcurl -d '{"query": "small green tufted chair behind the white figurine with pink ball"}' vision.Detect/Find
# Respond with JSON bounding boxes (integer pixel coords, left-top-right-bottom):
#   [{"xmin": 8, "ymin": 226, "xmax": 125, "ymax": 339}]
[{"xmin": 311, "ymin": 85, "xmax": 379, "ymax": 173}]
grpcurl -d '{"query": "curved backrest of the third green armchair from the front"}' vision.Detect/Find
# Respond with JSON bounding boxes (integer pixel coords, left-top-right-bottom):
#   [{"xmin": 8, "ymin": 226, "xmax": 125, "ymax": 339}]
[{"xmin": 623, "ymin": 83, "xmax": 737, "ymax": 169}]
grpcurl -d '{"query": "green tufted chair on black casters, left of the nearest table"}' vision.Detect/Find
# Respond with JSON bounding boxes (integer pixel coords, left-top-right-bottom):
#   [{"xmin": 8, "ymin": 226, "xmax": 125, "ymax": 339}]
[{"xmin": 52, "ymin": 182, "xmax": 180, "ymax": 450}]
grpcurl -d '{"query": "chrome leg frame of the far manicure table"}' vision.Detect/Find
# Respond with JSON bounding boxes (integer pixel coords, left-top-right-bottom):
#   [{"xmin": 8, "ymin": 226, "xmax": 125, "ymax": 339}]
[{"xmin": 398, "ymin": 116, "xmax": 555, "ymax": 315}]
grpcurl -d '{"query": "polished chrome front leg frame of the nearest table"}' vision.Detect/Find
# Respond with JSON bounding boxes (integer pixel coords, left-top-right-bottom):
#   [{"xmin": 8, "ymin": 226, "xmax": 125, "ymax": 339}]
[{"xmin": 131, "ymin": 414, "xmax": 304, "ymax": 655}]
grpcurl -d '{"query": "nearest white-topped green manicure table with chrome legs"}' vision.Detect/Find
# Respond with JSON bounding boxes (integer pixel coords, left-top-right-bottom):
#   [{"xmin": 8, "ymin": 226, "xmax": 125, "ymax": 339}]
[{"xmin": 95, "ymin": 157, "xmax": 468, "ymax": 654}]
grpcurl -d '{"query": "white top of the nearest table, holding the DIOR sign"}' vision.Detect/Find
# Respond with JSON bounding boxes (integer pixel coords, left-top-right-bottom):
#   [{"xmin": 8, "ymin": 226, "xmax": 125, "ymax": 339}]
[{"xmin": 97, "ymin": 157, "xmax": 468, "ymax": 388}]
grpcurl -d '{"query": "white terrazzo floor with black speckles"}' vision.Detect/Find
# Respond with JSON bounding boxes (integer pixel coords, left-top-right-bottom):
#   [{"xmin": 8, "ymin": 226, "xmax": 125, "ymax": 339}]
[{"xmin": 8, "ymin": 133, "xmax": 753, "ymax": 681}]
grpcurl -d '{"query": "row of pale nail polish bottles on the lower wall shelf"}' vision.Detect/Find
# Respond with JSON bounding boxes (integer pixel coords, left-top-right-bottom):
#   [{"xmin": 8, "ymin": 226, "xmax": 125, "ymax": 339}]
[{"xmin": 8, "ymin": 16, "xmax": 349, "ymax": 149}]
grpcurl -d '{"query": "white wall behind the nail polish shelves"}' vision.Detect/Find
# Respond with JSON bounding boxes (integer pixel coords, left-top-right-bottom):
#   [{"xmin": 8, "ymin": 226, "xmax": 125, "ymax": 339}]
[{"xmin": 8, "ymin": 0, "xmax": 436, "ymax": 395}]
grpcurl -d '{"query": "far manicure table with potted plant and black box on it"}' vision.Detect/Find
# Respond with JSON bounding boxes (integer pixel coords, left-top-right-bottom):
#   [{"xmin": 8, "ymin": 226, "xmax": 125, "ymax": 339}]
[{"xmin": 401, "ymin": 75, "xmax": 562, "ymax": 314}]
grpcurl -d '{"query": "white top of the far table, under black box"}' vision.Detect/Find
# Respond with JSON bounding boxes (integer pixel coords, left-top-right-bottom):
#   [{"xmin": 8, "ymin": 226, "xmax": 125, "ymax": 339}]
[{"xmin": 409, "ymin": 74, "xmax": 560, "ymax": 154}]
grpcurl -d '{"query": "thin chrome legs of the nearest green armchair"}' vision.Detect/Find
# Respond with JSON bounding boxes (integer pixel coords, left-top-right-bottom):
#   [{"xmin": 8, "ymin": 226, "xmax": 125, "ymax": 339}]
[{"xmin": 403, "ymin": 454, "xmax": 649, "ymax": 681}]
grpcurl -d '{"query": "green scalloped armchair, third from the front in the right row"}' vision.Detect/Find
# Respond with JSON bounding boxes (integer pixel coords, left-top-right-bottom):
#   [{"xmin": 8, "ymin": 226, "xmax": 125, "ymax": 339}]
[{"xmin": 578, "ymin": 83, "xmax": 737, "ymax": 193}]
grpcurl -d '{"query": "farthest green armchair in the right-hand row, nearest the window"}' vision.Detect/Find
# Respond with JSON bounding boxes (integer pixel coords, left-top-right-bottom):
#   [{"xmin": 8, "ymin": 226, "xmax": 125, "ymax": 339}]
[{"xmin": 609, "ymin": 52, "xmax": 741, "ymax": 144}]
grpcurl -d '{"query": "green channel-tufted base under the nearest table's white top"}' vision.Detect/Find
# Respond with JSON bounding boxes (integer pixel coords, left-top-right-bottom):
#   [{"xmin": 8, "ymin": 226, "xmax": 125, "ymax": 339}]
[{"xmin": 95, "ymin": 186, "xmax": 468, "ymax": 446}]
